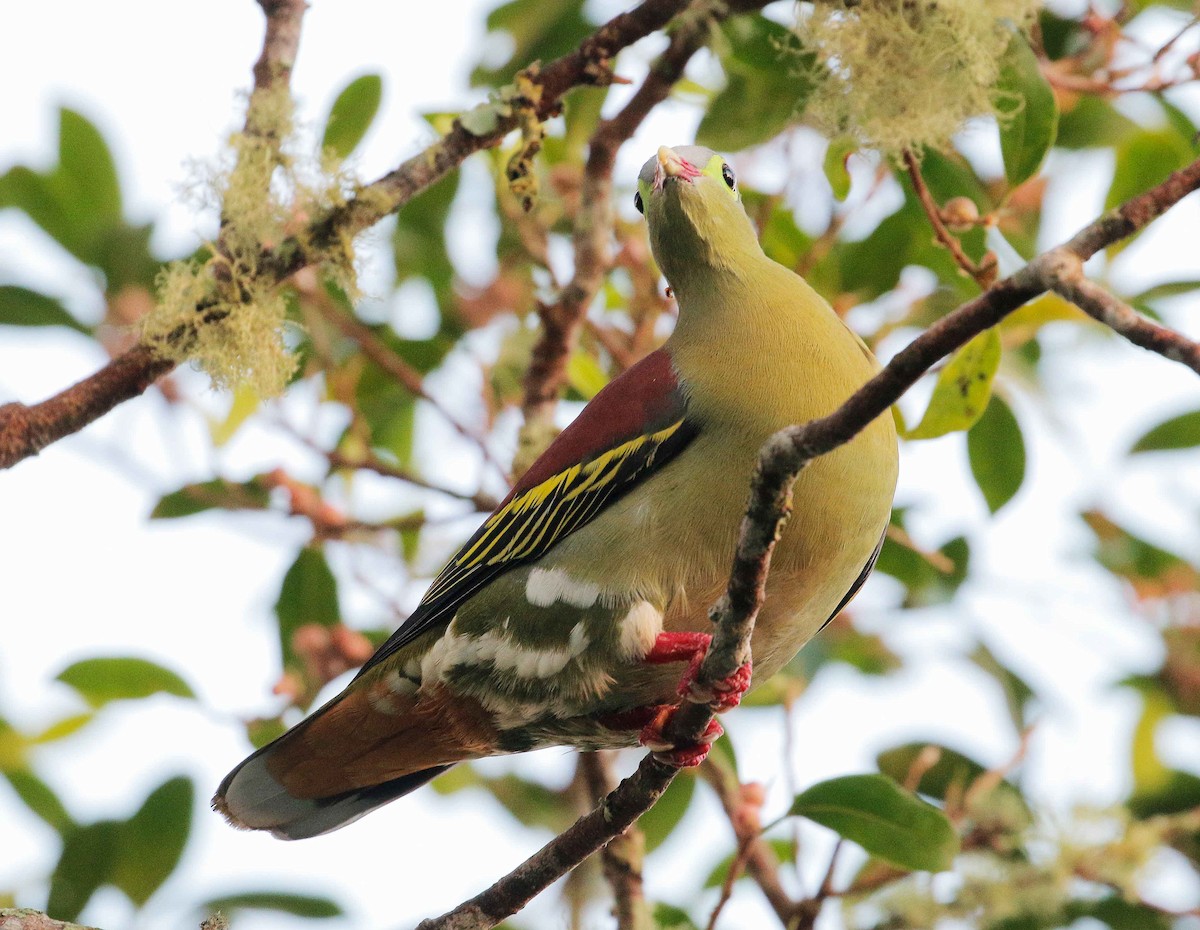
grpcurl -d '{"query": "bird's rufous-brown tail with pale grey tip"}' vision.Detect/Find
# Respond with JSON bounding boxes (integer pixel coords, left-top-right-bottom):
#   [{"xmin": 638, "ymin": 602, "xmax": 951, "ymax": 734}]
[{"xmin": 212, "ymin": 684, "xmax": 497, "ymax": 840}]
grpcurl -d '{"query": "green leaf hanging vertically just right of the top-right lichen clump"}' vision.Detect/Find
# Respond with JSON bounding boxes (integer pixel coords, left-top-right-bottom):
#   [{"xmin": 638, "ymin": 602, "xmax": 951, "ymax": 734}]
[{"xmin": 996, "ymin": 32, "xmax": 1058, "ymax": 187}]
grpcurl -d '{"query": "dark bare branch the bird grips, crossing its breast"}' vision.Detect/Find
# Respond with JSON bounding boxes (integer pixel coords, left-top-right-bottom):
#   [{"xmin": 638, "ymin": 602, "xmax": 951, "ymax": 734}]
[{"xmin": 418, "ymin": 160, "xmax": 1200, "ymax": 930}]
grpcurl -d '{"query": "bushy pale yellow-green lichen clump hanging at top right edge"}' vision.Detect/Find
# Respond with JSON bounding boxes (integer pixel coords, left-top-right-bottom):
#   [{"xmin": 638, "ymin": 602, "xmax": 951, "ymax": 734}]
[{"xmin": 797, "ymin": 0, "xmax": 1040, "ymax": 155}]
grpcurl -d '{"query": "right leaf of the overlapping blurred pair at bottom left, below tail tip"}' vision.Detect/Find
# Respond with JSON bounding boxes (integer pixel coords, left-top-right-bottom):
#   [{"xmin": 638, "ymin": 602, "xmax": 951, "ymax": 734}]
[{"xmin": 109, "ymin": 778, "xmax": 196, "ymax": 907}]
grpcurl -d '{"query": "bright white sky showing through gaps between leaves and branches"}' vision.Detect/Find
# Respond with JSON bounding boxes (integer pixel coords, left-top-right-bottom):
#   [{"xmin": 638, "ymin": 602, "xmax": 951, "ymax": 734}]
[{"xmin": 0, "ymin": 0, "xmax": 1200, "ymax": 930}]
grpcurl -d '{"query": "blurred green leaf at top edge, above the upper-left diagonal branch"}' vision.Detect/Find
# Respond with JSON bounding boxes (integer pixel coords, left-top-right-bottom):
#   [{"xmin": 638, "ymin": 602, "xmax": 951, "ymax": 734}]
[{"xmin": 470, "ymin": 0, "xmax": 592, "ymax": 86}]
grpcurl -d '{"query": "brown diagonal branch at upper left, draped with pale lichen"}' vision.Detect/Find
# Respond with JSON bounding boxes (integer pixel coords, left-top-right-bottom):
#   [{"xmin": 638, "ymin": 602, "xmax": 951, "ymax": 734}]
[{"xmin": 0, "ymin": 0, "xmax": 766, "ymax": 468}]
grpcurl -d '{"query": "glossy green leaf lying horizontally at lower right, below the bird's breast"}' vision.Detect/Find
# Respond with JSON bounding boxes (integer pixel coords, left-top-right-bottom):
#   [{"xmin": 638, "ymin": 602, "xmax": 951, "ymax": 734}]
[{"xmin": 788, "ymin": 775, "xmax": 959, "ymax": 872}]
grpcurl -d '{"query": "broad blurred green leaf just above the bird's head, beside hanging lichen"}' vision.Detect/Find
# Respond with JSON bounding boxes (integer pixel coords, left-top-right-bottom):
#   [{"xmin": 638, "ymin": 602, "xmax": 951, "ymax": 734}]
[{"xmin": 696, "ymin": 13, "xmax": 814, "ymax": 151}]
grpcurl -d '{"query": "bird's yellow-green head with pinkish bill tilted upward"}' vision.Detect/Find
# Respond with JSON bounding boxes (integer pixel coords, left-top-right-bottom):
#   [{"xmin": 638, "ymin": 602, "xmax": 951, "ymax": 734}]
[{"xmin": 635, "ymin": 145, "xmax": 761, "ymax": 290}]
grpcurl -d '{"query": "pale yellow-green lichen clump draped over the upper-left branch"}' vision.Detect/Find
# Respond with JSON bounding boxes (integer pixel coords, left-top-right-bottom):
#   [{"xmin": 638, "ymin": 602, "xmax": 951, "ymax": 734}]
[{"xmin": 142, "ymin": 82, "xmax": 358, "ymax": 397}]
